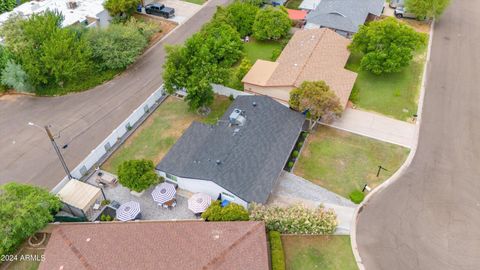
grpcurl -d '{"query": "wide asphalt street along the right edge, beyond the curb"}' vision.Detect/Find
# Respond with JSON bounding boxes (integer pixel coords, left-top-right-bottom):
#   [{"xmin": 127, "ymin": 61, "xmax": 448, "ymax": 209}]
[{"xmin": 357, "ymin": 0, "xmax": 480, "ymax": 270}]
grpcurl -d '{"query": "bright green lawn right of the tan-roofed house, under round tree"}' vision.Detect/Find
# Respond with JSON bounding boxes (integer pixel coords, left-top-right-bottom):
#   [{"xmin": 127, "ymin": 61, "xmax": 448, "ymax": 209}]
[{"xmin": 346, "ymin": 48, "xmax": 426, "ymax": 121}]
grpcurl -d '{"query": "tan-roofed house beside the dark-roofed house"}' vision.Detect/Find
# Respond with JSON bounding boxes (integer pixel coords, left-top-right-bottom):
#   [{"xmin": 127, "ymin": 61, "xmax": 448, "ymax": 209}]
[{"xmin": 242, "ymin": 28, "xmax": 357, "ymax": 107}]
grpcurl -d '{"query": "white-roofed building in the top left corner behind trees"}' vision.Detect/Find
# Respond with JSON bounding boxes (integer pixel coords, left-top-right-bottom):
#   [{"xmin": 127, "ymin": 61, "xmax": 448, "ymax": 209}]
[{"xmin": 0, "ymin": 0, "xmax": 111, "ymax": 27}]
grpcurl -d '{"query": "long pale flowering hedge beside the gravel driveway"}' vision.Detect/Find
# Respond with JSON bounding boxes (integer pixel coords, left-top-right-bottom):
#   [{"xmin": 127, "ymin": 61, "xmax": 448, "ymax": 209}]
[{"xmin": 250, "ymin": 203, "xmax": 337, "ymax": 234}]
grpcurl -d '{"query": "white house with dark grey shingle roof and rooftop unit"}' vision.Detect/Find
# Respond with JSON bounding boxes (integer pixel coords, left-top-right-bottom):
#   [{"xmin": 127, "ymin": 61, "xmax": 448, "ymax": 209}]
[{"xmin": 156, "ymin": 95, "xmax": 305, "ymax": 207}]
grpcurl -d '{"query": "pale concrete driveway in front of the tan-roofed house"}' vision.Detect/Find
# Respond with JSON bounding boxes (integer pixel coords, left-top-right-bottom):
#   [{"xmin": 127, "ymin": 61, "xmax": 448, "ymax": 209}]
[{"xmin": 322, "ymin": 108, "xmax": 415, "ymax": 148}]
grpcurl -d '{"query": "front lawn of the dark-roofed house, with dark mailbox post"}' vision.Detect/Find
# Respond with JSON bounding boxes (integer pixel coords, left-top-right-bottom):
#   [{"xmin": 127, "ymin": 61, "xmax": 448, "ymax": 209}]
[{"xmin": 294, "ymin": 126, "xmax": 410, "ymax": 198}]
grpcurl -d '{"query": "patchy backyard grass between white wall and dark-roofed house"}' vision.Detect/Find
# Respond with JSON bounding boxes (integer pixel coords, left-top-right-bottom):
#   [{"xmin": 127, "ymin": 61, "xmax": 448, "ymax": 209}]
[{"xmin": 102, "ymin": 96, "xmax": 231, "ymax": 174}]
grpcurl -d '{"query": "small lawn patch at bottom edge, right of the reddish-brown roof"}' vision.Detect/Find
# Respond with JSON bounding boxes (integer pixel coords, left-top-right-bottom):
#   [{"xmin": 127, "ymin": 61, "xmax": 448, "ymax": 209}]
[{"xmin": 282, "ymin": 235, "xmax": 358, "ymax": 270}]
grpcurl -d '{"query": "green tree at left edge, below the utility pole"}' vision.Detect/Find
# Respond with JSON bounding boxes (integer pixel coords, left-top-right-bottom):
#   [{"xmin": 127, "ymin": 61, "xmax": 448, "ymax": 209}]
[{"xmin": 0, "ymin": 183, "xmax": 61, "ymax": 255}]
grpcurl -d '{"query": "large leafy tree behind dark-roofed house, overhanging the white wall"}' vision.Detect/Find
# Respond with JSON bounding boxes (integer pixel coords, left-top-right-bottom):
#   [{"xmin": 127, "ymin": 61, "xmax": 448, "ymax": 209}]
[{"xmin": 163, "ymin": 21, "xmax": 243, "ymax": 110}]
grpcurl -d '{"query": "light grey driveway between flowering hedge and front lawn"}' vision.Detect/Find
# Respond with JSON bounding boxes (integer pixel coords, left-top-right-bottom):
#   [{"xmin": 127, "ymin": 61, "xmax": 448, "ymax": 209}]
[{"xmin": 267, "ymin": 171, "xmax": 356, "ymax": 235}]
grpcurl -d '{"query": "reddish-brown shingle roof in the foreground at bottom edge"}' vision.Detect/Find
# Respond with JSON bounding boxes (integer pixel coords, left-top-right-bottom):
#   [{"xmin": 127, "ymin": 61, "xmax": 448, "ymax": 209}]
[{"xmin": 39, "ymin": 221, "xmax": 269, "ymax": 270}]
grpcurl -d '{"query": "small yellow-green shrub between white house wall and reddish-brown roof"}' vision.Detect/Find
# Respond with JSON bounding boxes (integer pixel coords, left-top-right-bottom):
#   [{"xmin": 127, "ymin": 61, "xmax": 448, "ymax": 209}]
[{"xmin": 202, "ymin": 201, "xmax": 249, "ymax": 221}]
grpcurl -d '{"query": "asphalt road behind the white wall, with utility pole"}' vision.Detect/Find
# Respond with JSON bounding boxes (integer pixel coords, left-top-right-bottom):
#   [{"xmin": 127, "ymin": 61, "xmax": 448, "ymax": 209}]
[{"xmin": 0, "ymin": 0, "xmax": 229, "ymax": 188}]
